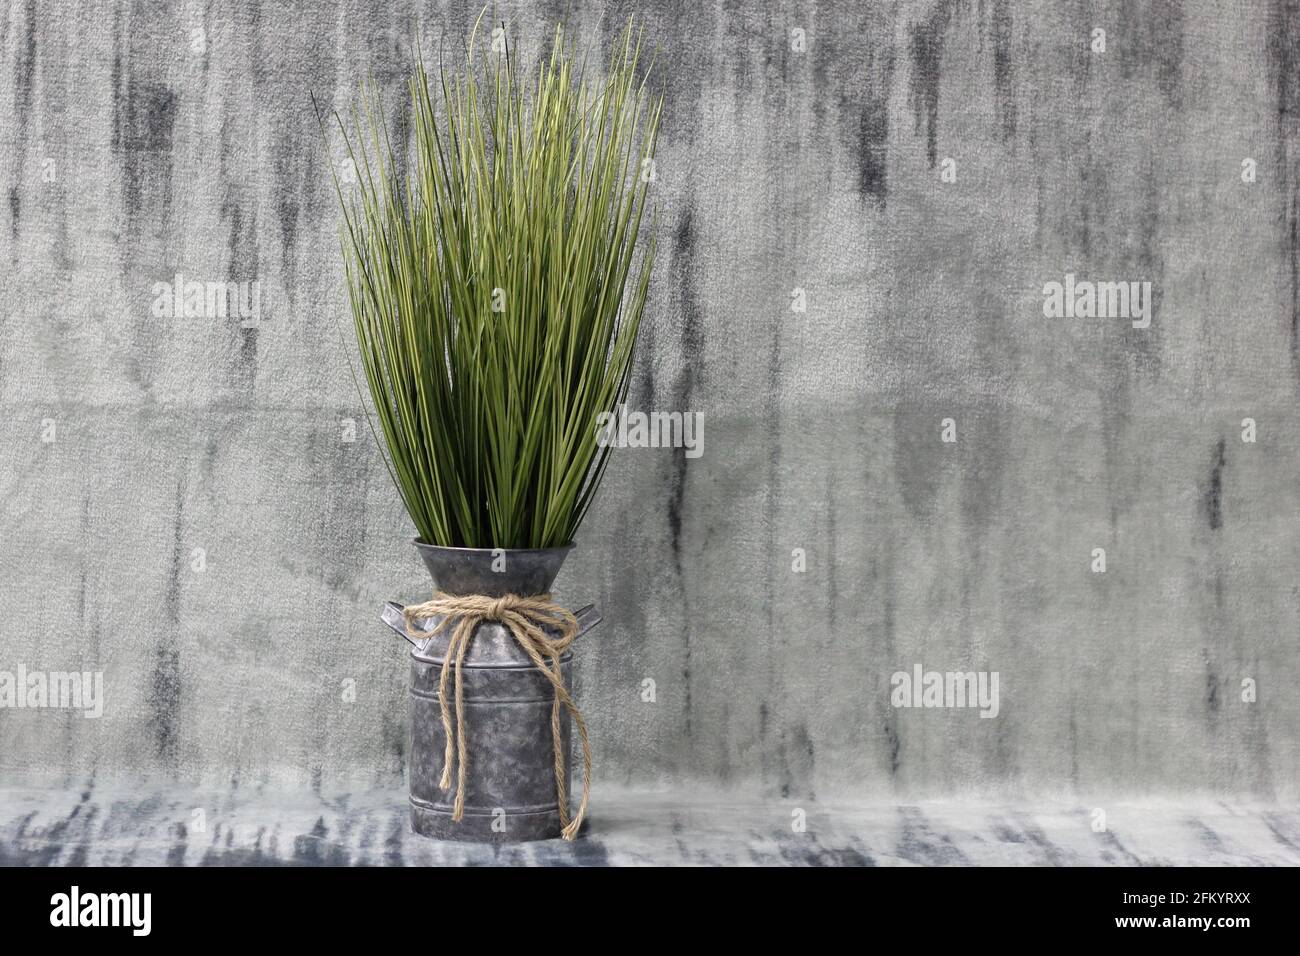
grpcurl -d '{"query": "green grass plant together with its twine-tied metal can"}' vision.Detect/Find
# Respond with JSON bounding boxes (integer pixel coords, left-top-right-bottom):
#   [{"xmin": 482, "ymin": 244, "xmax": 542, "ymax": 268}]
[{"xmin": 327, "ymin": 17, "xmax": 662, "ymax": 840}]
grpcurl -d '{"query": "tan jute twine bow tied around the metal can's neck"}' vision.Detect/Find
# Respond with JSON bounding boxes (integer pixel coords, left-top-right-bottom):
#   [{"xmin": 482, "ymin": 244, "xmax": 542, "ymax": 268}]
[{"xmin": 403, "ymin": 591, "xmax": 592, "ymax": 840}]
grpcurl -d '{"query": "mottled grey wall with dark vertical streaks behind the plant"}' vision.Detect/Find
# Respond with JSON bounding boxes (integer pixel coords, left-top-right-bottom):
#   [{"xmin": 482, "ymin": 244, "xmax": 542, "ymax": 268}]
[{"xmin": 0, "ymin": 0, "xmax": 1300, "ymax": 799}]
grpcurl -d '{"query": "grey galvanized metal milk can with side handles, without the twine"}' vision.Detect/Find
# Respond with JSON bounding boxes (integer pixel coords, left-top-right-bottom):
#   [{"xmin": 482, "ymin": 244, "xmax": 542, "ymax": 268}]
[{"xmin": 382, "ymin": 541, "xmax": 601, "ymax": 843}]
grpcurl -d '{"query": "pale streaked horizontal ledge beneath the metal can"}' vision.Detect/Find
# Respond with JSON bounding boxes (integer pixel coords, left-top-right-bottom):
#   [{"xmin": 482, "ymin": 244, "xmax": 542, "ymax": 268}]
[{"xmin": 0, "ymin": 788, "xmax": 1300, "ymax": 866}]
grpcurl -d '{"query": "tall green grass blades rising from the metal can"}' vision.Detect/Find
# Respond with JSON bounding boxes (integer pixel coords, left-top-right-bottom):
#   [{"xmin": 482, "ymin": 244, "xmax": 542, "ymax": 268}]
[{"xmin": 335, "ymin": 16, "xmax": 663, "ymax": 548}]
